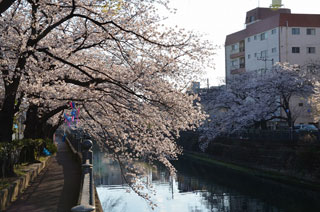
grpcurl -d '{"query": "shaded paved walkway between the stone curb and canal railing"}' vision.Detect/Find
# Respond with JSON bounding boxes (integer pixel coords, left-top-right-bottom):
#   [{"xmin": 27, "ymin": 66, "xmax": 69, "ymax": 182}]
[{"xmin": 6, "ymin": 137, "xmax": 81, "ymax": 212}]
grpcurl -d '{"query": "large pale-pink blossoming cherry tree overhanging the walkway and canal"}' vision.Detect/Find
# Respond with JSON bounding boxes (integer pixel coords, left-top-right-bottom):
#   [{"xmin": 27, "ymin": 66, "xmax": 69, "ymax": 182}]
[{"xmin": 0, "ymin": 0, "xmax": 213, "ymax": 199}]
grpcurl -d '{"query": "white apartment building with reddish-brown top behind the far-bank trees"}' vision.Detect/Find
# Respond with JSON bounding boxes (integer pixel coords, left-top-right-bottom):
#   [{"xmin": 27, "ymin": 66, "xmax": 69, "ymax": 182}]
[{"xmin": 225, "ymin": 8, "xmax": 320, "ymax": 123}]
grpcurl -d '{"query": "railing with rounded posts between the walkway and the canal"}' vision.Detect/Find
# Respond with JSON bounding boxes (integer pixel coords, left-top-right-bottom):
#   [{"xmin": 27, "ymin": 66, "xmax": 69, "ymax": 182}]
[{"xmin": 66, "ymin": 128, "xmax": 95, "ymax": 212}]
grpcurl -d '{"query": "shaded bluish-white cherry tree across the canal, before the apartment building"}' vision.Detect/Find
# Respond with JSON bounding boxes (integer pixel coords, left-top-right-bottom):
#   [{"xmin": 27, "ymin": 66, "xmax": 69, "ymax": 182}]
[{"xmin": 200, "ymin": 64, "xmax": 315, "ymax": 147}]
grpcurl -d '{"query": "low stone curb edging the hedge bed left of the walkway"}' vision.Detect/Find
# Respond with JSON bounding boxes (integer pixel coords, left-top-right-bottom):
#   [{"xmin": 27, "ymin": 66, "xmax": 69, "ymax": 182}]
[{"xmin": 0, "ymin": 156, "xmax": 52, "ymax": 211}]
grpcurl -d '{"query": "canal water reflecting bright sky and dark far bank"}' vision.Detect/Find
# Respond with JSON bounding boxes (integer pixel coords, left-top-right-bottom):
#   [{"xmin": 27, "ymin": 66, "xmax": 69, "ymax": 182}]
[{"xmin": 94, "ymin": 154, "xmax": 320, "ymax": 212}]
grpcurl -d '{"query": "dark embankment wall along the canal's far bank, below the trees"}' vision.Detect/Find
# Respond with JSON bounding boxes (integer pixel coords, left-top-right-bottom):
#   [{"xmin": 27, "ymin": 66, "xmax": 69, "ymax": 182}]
[{"xmin": 179, "ymin": 132, "xmax": 320, "ymax": 183}]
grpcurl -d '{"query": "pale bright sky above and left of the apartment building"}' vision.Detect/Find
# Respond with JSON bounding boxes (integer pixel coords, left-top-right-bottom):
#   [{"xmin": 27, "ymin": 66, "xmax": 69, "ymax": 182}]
[{"xmin": 167, "ymin": 0, "xmax": 320, "ymax": 86}]
